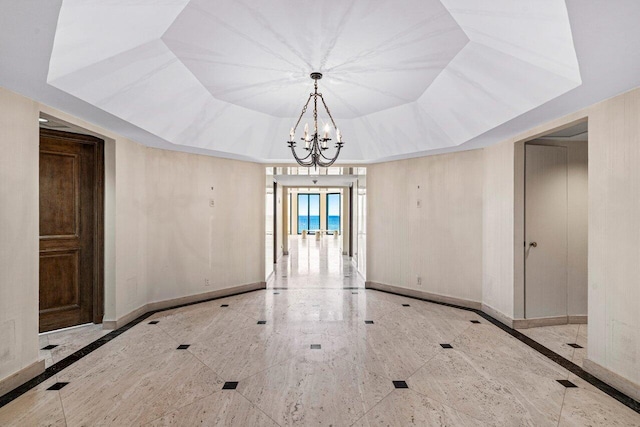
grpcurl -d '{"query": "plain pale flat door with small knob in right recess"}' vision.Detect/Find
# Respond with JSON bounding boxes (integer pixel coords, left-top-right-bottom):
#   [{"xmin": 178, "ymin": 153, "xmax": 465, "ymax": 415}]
[{"xmin": 524, "ymin": 144, "xmax": 567, "ymax": 319}]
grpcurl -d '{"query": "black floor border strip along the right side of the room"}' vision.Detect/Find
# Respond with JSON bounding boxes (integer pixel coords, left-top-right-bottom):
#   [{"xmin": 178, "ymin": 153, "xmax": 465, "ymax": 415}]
[{"xmin": 367, "ymin": 288, "xmax": 640, "ymax": 414}]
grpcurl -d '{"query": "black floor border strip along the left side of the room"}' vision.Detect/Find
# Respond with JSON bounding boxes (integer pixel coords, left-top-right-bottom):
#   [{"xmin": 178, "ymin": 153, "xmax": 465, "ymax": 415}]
[{"xmin": 0, "ymin": 289, "xmax": 265, "ymax": 408}]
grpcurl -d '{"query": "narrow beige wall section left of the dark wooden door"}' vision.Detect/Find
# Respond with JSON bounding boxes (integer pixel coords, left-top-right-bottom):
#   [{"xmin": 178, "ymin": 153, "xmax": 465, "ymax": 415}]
[{"xmin": 0, "ymin": 88, "xmax": 39, "ymax": 384}]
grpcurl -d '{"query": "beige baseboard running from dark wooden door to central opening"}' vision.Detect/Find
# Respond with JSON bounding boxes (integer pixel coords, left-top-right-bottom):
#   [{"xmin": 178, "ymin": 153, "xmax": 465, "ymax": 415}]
[{"xmin": 102, "ymin": 282, "xmax": 267, "ymax": 329}]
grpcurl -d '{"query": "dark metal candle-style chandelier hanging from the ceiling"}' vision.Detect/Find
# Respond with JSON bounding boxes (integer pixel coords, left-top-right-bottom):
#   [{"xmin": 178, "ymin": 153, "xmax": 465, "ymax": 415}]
[{"xmin": 287, "ymin": 73, "xmax": 344, "ymax": 168}]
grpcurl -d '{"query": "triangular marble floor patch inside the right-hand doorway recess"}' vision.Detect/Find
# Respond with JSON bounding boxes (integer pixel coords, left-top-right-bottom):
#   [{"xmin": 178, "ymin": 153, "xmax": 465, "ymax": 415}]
[{"xmin": 518, "ymin": 324, "xmax": 587, "ymax": 367}]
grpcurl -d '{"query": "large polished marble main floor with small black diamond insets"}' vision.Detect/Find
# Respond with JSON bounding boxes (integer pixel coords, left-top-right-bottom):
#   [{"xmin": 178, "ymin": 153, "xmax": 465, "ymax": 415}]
[{"xmin": 0, "ymin": 237, "xmax": 640, "ymax": 427}]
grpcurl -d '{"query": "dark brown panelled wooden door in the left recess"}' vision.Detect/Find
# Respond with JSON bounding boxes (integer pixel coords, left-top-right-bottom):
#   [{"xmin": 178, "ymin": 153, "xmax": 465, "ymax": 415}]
[{"xmin": 40, "ymin": 129, "xmax": 103, "ymax": 332}]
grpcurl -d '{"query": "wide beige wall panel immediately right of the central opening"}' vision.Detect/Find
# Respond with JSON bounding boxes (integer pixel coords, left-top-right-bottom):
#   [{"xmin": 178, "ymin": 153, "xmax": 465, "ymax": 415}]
[{"xmin": 366, "ymin": 150, "xmax": 483, "ymax": 302}]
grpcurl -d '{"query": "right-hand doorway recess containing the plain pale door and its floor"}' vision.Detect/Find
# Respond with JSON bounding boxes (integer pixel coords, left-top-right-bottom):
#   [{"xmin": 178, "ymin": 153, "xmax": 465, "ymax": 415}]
[{"xmin": 516, "ymin": 119, "xmax": 589, "ymax": 364}]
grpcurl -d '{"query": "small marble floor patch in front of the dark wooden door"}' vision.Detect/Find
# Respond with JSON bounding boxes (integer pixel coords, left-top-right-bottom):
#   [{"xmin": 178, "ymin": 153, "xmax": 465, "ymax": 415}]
[{"xmin": 38, "ymin": 323, "xmax": 111, "ymax": 368}]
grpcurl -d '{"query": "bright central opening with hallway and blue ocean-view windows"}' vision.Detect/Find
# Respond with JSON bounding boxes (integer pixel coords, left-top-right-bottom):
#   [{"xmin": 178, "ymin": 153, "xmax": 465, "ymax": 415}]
[{"xmin": 265, "ymin": 167, "xmax": 366, "ymax": 288}]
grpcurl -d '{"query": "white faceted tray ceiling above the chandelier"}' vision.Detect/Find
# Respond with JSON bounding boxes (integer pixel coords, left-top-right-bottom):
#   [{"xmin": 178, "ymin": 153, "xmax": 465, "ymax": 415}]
[{"xmin": 0, "ymin": 0, "xmax": 640, "ymax": 163}]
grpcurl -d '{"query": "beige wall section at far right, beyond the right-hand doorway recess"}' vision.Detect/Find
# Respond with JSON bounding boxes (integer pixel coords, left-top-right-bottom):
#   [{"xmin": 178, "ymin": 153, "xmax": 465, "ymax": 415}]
[{"xmin": 588, "ymin": 90, "xmax": 640, "ymax": 392}]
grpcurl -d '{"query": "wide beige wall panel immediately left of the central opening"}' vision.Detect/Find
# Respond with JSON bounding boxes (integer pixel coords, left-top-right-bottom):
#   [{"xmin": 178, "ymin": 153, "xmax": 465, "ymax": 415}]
[{"xmin": 144, "ymin": 148, "xmax": 265, "ymax": 302}]
